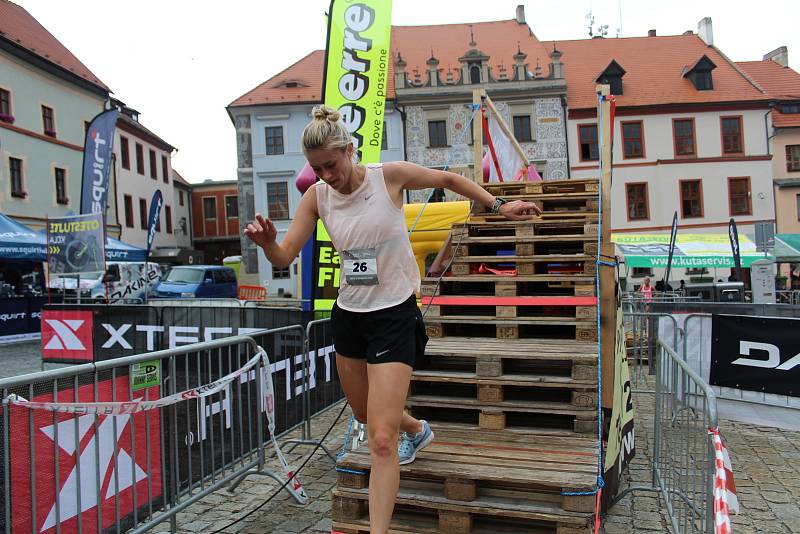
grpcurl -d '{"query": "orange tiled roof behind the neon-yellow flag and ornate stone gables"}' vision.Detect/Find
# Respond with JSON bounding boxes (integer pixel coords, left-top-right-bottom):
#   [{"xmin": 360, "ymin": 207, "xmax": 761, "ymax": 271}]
[{"xmin": 230, "ymin": 19, "xmax": 550, "ymax": 107}]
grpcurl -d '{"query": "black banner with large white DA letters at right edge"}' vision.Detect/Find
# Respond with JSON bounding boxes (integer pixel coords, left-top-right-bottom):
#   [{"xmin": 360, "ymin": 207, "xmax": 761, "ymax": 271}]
[{"xmin": 709, "ymin": 315, "xmax": 800, "ymax": 396}]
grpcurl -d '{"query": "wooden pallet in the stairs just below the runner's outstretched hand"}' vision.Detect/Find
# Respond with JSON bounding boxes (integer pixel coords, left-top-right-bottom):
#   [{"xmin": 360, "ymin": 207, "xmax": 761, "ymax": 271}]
[{"xmin": 451, "ymin": 219, "xmax": 598, "ymax": 243}]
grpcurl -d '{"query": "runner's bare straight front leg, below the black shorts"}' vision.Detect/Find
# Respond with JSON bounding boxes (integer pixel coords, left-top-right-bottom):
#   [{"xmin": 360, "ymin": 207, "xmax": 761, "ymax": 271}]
[{"xmin": 367, "ymin": 362, "xmax": 418, "ymax": 534}]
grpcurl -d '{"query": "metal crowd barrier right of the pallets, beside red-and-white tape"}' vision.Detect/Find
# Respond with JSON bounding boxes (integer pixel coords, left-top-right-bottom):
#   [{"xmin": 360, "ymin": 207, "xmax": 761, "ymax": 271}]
[{"xmin": 612, "ymin": 341, "xmax": 718, "ymax": 534}]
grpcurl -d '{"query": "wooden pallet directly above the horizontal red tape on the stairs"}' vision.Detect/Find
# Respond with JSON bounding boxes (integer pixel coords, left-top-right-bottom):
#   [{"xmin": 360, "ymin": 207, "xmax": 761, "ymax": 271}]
[{"xmin": 422, "ymin": 274, "xmax": 595, "ymax": 297}]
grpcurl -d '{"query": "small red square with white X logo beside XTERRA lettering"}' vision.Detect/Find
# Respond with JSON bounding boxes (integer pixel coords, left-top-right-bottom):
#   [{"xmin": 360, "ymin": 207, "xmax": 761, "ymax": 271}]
[{"xmin": 42, "ymin": 310, "xmax": 93, "ymax": 361}]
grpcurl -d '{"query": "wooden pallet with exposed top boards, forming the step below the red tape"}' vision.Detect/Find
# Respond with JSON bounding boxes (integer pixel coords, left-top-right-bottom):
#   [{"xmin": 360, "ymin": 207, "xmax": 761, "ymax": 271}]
[{"xmin": 423, "ymin": 337, "xmax": 597, "ymax": 384}]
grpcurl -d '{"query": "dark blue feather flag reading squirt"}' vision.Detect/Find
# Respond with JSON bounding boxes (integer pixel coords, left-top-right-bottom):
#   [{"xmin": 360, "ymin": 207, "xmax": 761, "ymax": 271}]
[{"xmin": 81, "ymin": 109, "xmax": 119, "ymax": 220}]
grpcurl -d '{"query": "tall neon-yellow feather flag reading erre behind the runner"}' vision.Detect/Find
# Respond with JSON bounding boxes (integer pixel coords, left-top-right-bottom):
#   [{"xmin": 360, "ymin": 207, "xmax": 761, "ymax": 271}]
[{"xmin": 312, "ymin": 0, "xmax": 392, "ymax": 311}]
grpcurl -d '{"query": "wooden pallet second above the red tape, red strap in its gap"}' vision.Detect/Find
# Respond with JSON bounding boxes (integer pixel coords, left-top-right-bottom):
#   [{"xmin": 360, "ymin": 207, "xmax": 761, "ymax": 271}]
[{"xmin": 450, "ymin": 254, "xmax": 597, "ymax": 276}]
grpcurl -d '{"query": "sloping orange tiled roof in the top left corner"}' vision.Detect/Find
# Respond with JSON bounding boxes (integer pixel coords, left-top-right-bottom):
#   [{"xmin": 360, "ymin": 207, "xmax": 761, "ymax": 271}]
[{"xmin": 0, "ymin": 0, "xmax": 111, "ymax": 92}]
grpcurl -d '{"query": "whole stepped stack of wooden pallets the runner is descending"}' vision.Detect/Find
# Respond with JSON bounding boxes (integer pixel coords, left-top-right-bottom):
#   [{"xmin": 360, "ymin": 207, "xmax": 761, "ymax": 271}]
[{"xmin": 333, "ymin": 180, "xmax": 599, "ymax": 534}]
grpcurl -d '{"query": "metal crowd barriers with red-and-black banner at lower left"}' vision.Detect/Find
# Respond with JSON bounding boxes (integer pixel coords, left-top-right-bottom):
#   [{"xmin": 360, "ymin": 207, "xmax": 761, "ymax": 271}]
[{"xmin": 0, "ymin": 325, "xmax": 332, "ymax": 534}]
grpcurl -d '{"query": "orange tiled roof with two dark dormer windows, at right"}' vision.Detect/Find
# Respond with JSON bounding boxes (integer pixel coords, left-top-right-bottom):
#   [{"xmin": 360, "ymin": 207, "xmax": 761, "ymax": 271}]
[{"xmin": 544, "ymin": 34, "xmax": 769, "ymax": 109}]
